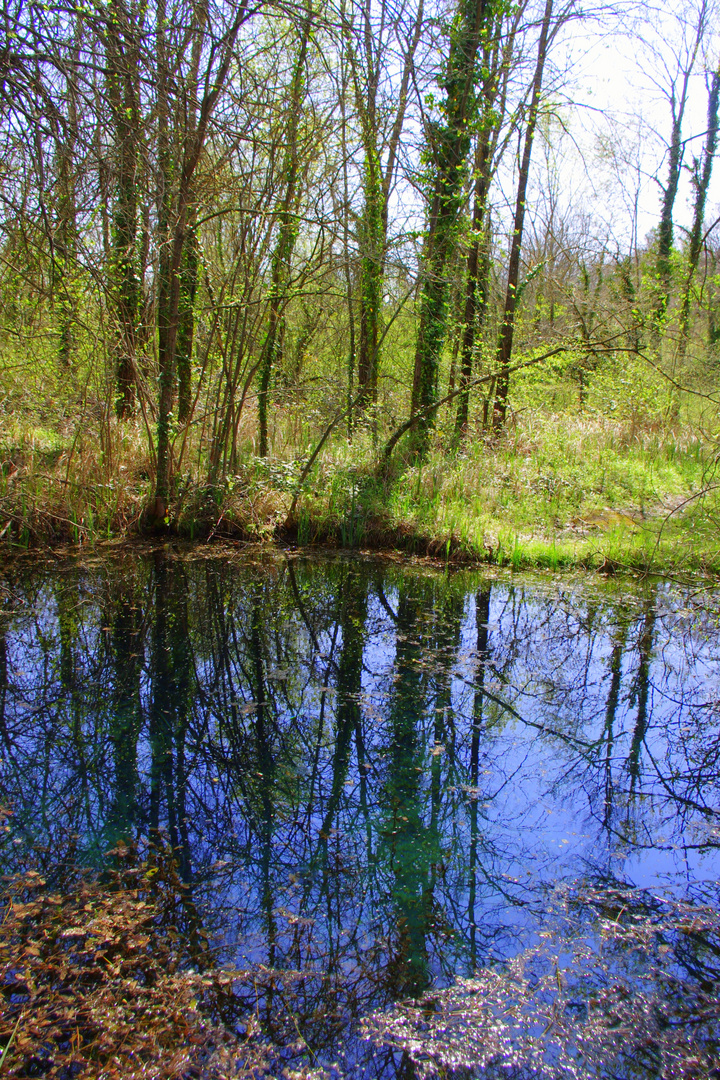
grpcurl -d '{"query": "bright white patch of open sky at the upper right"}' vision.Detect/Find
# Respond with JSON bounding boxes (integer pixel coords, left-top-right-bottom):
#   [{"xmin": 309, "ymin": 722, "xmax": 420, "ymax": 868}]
[{"xmin": 546, "ymin": 2, "xmax": 720, "ymax": 245}]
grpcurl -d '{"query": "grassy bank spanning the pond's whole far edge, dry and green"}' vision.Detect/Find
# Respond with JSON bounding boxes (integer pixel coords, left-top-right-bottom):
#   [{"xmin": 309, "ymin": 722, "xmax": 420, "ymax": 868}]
[{"xmin": 0, "ymin": 408, "xmax": 720, "ymax": 572}]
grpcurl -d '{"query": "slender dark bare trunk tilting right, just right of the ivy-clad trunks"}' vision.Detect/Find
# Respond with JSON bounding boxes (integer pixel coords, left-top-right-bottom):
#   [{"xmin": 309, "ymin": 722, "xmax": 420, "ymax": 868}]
[{"xmin": 492, "ymin": 0, "xmax": 553, "ymax": 431}]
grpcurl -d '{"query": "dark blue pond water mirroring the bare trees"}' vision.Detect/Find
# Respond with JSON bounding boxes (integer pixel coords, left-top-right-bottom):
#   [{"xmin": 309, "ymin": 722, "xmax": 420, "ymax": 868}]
[{"xmin": 0, "ymin": 549, "xmax": 720, "ymax": 1076}]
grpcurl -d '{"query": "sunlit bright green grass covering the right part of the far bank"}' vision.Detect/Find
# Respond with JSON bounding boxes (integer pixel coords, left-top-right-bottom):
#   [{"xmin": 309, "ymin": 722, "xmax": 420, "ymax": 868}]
[{"xmin": 287, "ymin": 415, "xmax": 720, "ymax": 571}]
